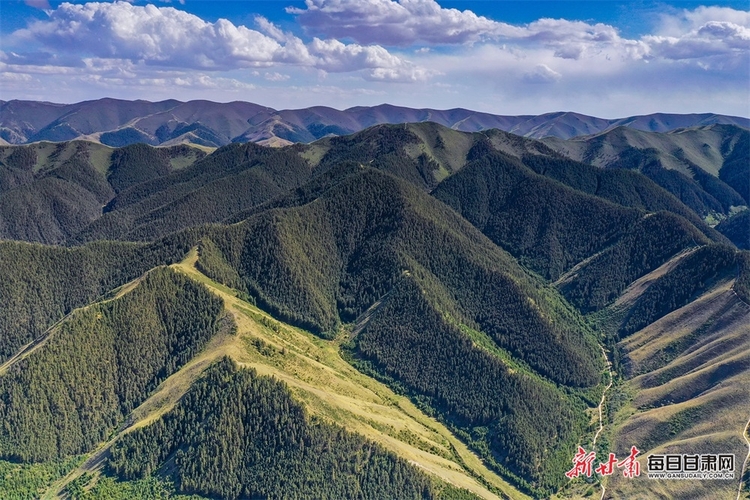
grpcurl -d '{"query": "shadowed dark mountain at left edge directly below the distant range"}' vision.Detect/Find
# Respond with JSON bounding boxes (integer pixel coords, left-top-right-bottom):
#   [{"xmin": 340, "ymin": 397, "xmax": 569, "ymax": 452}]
[{"xmin": 0, "ymin": 141, "xmax": 205, "ymax": 244}]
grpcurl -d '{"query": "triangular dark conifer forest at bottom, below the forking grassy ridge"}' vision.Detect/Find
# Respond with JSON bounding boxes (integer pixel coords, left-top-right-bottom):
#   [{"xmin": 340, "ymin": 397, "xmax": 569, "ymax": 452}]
[{"xmin": 108, "ymin": 358, "xmax": 458, "ymax": 500}]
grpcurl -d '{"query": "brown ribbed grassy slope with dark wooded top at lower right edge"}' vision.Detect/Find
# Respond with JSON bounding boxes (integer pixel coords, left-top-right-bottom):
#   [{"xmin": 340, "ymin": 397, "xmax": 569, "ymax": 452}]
[{"xmin": 592, "ymin": 250, "xmax": 750, "ymax": 499}]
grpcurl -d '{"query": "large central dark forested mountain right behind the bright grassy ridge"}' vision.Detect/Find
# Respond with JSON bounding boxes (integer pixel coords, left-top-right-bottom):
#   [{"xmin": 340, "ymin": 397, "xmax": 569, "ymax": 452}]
[{"xmin": 192, "ymin": 168, "xmax": 602, "ymax": 494}]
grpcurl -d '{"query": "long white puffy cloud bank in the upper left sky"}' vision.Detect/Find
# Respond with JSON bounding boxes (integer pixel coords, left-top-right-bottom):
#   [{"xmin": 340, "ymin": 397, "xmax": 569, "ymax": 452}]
[{"xmin": 15, "ymin": 2, "xmax": 426, "ymax": 81}]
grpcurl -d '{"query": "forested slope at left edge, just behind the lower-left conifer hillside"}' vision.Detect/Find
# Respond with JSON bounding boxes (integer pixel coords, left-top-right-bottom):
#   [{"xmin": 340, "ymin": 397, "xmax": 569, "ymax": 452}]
[{"xmin": 0, "ymin": 232, "xmax": 200, "ymax": 362}]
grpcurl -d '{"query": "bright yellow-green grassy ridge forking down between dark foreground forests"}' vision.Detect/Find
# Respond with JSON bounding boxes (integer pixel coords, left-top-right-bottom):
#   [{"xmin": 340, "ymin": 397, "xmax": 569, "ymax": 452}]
[{"xmin": 8, "ymin": 252, "xmax": 525, "ymax": 498}]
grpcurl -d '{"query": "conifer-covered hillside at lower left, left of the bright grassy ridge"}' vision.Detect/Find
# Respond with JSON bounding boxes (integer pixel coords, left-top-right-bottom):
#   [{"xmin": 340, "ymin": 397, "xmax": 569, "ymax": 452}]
[{"xmin": 0, "ymin": 269, "xmax": 226, "ymax": 462}]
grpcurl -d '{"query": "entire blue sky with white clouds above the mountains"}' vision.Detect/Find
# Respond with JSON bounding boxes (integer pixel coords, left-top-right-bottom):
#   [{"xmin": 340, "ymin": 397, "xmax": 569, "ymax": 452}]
[{"xmin": 0, "ymin": 0, "xmax": 750, "ymax": 118}]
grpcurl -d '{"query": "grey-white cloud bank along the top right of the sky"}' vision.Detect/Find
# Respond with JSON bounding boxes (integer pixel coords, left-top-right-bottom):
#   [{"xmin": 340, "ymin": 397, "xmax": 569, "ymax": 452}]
[{"xmin": 294, "ymin": 0, "xmax": 750, "ymax": 67}]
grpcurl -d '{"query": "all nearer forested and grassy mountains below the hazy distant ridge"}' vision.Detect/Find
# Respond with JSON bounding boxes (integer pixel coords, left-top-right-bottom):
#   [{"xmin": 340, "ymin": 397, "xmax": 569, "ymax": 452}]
[{"xmin": 0, "ymin": 110, "xmax": 750, "ymax": 499}]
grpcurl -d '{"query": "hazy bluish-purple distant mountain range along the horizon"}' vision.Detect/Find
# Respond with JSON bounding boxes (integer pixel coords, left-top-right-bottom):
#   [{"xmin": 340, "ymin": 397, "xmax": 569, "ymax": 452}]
[{"xmin": 0, "ymin": 98, "xmax": 750, "ymax": 147}]
